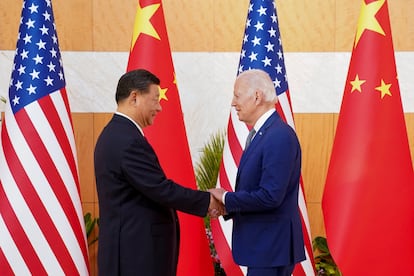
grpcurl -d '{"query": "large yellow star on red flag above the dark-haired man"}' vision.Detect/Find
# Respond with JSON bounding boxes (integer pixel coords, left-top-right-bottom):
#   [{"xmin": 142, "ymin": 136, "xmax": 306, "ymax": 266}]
[{"xmin": 131, "ymin": 1, "xmax": 160, "ymax": 48}]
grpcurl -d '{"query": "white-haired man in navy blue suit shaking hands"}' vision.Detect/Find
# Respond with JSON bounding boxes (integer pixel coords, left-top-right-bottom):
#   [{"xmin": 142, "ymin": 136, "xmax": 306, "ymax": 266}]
[{"xmin": 211, "ymin": 70, "xmax": 305, "ymax": 276}]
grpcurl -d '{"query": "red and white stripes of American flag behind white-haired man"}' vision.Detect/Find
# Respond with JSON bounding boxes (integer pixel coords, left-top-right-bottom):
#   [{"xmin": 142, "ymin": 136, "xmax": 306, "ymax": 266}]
[{"xmin": 211, "ymin": 91, "xmax": 315, "ymax": 276}]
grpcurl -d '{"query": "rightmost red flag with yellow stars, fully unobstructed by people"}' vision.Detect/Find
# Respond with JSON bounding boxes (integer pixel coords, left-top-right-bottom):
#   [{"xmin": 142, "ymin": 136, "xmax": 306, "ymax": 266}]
[{"xmin": 322, "ymin": 0, "xmax": 414, "ymax": 275}]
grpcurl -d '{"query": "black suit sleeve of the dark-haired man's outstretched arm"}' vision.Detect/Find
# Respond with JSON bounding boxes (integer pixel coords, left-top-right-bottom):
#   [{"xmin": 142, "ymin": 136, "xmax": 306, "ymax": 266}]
[{"xmin": 121, "ymin": 137, "xmax": 210, "ymax": 217}]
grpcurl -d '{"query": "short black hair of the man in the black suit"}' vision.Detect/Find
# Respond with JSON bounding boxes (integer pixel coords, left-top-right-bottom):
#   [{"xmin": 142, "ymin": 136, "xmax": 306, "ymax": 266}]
[{"xmin": 115, "ymin": 69, "xmax": 160, "ymax": 103}]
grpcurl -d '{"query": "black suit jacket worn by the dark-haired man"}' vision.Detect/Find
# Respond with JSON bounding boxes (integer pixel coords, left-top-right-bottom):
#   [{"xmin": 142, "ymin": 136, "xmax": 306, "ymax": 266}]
[{"xmin": 94, "ymin": 114, "xmax": 210, "ymax": 276}]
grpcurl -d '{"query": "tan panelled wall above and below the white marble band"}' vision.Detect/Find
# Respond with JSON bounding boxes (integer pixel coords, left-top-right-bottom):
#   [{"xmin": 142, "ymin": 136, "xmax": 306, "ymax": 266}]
[{"xmin": 0, "ymin": 0, "xmax": 414, "ymax": 275}]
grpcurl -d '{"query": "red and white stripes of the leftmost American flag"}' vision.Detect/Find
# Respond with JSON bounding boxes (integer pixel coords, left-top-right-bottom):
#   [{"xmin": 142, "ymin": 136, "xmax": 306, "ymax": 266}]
[{"xmin": 0, "ymin": 88, "xmax": 89, "ymax": 275}]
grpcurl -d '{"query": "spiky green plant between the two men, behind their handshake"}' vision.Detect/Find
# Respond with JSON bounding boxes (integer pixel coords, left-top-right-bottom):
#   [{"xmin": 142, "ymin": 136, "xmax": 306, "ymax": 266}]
[{"xmin": 195, "ymin": 132, "xmax": 226, "ymax": 276}]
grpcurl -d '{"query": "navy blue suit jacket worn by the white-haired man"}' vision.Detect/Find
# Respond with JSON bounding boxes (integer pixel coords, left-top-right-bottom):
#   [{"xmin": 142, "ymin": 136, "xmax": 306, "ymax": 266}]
[{"xmin": 225, "ymin": 112, "xmax": 305, "ymax": 267}]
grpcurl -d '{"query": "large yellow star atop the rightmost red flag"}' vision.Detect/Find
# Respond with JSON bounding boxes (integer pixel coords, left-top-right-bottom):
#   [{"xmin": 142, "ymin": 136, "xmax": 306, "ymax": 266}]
[{"xmin": 354, "ymin": 0, "xmax": 385, "ymax": 48}]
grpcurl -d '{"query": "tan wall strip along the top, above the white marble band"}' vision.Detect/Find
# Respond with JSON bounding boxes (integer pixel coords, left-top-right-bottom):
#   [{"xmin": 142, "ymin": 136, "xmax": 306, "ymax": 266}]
[{"xmin": 0, "ymin": 0, "xmax": 414, "ymax": 52}]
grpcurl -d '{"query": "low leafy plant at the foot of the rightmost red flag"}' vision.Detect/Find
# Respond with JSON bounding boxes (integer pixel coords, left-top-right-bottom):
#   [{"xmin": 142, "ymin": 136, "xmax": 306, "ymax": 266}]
[{"xmin": 312, "ymin": 236, "xmax": 342, "ymax": 276}]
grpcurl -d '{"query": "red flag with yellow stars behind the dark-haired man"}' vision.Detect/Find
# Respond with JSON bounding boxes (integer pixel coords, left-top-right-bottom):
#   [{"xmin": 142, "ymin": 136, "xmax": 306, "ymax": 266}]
[{"xmin": 127, "ymin": 0, "xmax": 214, "ymax": 276}]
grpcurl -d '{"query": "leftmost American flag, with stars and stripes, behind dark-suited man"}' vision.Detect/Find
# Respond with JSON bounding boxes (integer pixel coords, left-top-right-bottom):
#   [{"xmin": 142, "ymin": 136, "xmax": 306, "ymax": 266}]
[{"xmin": 0, "ymin": 0, "xmax": 89, "ymax": 275}]
